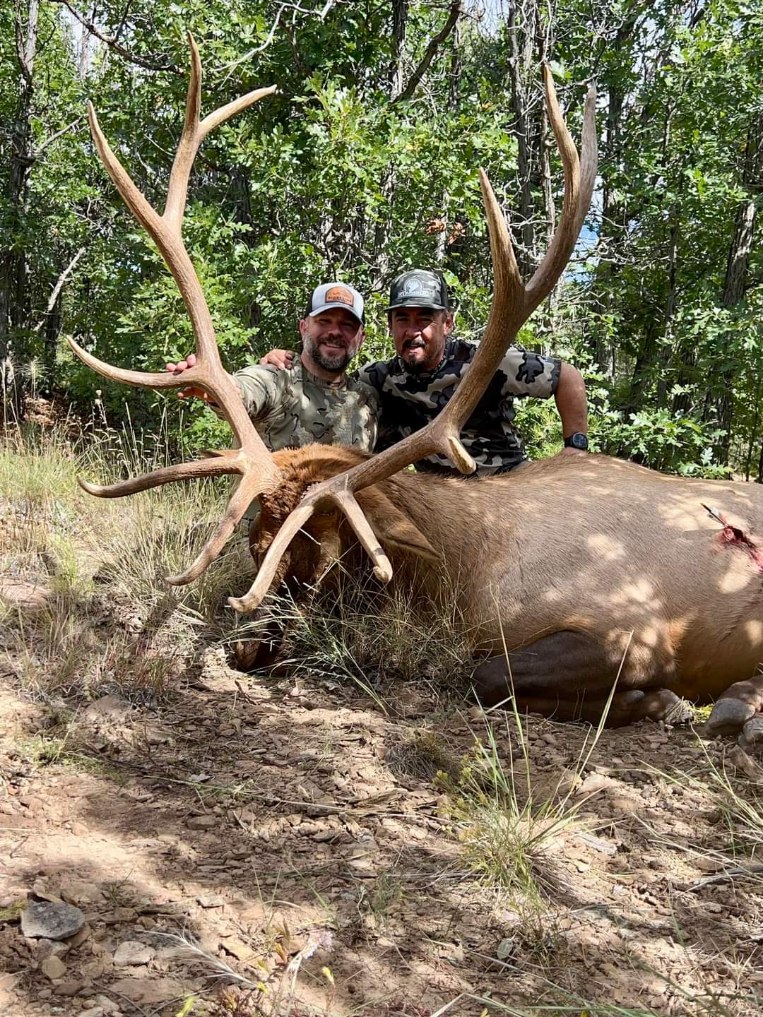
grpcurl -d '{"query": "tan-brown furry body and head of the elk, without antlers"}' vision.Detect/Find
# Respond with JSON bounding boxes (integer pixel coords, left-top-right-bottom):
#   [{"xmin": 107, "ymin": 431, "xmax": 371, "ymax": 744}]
[{"xmin": 248, "ymin": 445, "xmax": 763, "ymax": 731}]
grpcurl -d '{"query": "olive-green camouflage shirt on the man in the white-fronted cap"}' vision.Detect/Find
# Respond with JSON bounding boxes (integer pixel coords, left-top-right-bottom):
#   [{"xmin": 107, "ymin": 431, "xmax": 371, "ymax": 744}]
[{"xmin": 233, "ymin": 357, "xmax": 378, "ymax": 452}]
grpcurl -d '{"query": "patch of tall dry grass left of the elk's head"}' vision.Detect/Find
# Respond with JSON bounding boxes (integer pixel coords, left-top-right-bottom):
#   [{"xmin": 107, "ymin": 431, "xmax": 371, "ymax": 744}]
[{"xmin": 0, "ymin": 416, "xmax": 247, "ymax": 699}]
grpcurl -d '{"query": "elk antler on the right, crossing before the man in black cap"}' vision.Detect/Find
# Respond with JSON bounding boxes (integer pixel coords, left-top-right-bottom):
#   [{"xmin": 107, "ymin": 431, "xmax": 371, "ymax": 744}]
[{"xmin": 228, "ymin": 66, "xmax": 597, "ymax": 611}]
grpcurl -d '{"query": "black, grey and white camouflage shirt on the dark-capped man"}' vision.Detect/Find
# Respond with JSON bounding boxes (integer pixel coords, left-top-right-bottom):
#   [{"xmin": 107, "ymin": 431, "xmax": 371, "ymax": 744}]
[{"xmin": 359, "ymin": 339, "xmax": 562, "ymax": 474}]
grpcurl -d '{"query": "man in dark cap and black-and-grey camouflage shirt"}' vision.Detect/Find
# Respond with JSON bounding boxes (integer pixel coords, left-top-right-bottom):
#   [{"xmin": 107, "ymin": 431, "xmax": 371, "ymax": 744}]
[{"xmin": 263, "ymin": 268, "xmax": 588, "ymax": 475}]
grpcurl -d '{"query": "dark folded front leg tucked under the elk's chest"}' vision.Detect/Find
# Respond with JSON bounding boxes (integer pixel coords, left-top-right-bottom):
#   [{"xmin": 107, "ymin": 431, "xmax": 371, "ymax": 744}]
[{"xmin": 473, "ymin": 632, "xmax": 690, "ymax": 725}]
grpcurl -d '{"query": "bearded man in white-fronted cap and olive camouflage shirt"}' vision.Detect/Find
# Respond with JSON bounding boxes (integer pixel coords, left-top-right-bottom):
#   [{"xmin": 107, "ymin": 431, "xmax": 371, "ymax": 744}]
[{"xmin": 167, "ymin": 283, "xmax": 378, "ymax": 452}]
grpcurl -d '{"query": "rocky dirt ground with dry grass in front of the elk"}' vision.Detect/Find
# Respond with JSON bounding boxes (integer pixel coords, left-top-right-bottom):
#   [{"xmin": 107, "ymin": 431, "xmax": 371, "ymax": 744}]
[{"xmin": 0, "ymin": 423, "xmax": 763, "ymax": 1017}]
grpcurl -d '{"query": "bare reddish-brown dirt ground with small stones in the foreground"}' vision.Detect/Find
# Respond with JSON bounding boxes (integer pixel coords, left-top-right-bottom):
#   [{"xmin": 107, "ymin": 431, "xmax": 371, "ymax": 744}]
[{"xmin": 0, "ymin": 626, "xmax": 763, "ymax": 1017}]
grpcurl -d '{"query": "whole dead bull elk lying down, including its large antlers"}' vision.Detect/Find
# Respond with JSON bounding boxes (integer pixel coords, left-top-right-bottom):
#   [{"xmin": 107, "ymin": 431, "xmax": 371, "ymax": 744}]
[{"xmin": 71, "ymin": 40, "xmax": 763, "ymax": 733}]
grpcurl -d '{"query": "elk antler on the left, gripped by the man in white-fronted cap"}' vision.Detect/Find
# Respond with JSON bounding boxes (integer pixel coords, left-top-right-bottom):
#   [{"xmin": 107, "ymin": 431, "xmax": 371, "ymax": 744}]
[{"xmin": 69, "ymin": 34, "xmax": 280, "ymax": 586}]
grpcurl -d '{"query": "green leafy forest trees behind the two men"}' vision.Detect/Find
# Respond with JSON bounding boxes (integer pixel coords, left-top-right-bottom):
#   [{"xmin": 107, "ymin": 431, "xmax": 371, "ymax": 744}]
[{"xmin": 0, "ymin": 0, "xmax": 763, "ymax": 482}]
